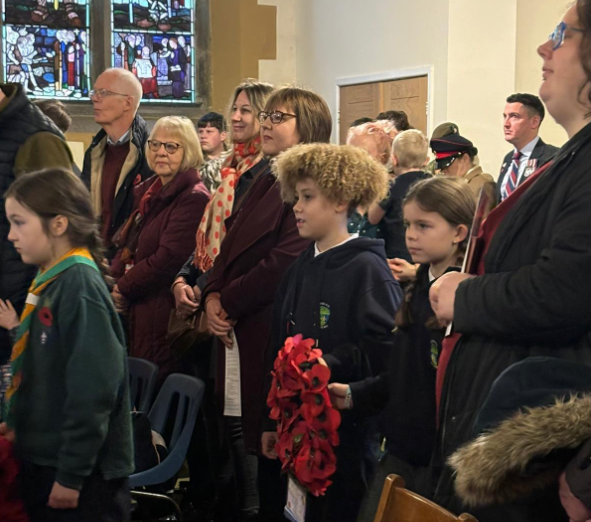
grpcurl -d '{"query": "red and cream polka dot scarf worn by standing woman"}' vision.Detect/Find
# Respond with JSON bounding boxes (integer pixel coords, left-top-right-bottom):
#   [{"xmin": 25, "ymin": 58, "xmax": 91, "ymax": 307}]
[{"xmin": 195, "ymin": 136, "xmax": 263, "ymax": 272}]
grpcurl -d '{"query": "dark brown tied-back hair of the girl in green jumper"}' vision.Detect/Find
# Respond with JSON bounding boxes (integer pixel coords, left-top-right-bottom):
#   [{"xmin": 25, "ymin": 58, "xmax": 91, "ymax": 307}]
[{"xmin": 4, "ymin": 168, "xmax": 112, "ymax": 285}]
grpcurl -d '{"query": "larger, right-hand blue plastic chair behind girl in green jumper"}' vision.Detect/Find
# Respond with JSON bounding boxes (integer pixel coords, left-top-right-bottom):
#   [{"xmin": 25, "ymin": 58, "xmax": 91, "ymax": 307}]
[{"xmin": 129, "ymin": 373, "xmax": 205, "ymax": 520}]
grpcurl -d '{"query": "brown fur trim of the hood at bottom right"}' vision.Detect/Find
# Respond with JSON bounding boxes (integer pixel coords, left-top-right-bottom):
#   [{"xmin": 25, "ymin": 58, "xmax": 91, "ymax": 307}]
[{"xmin": 448, "ymin": 393, "xmax": 591, "ymax": 506}]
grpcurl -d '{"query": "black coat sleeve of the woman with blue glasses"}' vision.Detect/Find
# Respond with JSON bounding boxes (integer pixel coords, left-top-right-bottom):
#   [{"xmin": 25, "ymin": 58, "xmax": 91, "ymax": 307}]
[{"xmin": 454, "ymin": 165, "xmax": 591, "ymax": 342}]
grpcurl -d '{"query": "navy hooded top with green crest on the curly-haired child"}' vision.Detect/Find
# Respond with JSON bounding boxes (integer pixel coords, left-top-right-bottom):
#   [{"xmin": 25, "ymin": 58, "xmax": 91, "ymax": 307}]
[{"xmin": 268, "ymin": 237, "xmax": 402, "ymax": 383}]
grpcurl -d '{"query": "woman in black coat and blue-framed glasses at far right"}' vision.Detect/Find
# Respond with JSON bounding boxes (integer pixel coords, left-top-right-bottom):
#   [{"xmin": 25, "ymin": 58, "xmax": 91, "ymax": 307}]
[{"xmin": 431, "ymin": 0, "xmax": 591, "ymax": 522}]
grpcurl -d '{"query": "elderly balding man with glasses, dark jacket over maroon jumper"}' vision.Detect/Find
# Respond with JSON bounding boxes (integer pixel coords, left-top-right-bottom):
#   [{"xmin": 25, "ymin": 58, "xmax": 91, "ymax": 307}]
[{"xmin": 82, "ymin": 68, "xmax": 150, "ymax": 259}]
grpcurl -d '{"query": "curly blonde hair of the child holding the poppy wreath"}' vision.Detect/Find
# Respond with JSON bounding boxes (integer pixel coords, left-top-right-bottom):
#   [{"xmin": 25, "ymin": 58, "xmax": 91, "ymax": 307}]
[{"xmin": 273, "ymin": 143, "xmax": 388, "ymax": 210}]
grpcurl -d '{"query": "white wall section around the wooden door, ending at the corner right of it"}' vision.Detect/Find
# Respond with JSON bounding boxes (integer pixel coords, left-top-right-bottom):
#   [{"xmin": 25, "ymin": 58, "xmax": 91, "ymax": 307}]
[{"xmin": 296, "ymin": 0, "xmax": 448, "ymax": 141}]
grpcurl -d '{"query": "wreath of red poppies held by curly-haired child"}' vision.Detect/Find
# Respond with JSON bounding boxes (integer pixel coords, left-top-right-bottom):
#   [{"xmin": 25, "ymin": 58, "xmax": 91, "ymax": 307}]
[{"xmin": 267, "ymin": 335, "xmax": 341, "ymax": 496}]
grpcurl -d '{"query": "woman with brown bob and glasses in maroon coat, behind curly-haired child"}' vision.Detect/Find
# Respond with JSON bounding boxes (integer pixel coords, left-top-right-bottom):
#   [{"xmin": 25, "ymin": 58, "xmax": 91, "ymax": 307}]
[{"xmin": 203, "ymin": 87, "xmax": 332, "ymax": 518}]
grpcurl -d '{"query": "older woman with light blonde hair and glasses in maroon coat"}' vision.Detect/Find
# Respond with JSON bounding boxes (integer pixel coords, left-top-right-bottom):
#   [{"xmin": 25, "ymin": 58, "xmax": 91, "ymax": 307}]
[{"xmin": 112, "ymin": 116, "xmax": 209, "ymax": 383}]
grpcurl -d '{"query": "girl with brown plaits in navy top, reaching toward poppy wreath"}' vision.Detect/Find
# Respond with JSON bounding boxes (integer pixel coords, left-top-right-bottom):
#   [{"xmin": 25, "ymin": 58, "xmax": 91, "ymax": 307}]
[{"xmin": 329, "ymin": 177, "xmax": 475, "ymax": 522}]
